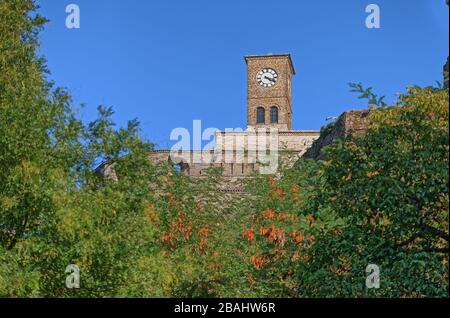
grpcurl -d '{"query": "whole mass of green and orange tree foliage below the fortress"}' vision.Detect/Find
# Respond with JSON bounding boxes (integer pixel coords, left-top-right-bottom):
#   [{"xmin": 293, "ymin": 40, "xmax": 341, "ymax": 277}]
[{"xmin": 0, "ymin": 0, "xmax": 449, "ymax": 297}]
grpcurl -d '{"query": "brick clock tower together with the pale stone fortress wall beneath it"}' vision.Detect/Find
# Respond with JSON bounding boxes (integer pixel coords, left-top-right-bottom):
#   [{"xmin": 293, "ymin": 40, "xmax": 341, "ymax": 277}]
[{"xmin": 142, "ymin": 54, "xmax": 320, "ymax": 186}]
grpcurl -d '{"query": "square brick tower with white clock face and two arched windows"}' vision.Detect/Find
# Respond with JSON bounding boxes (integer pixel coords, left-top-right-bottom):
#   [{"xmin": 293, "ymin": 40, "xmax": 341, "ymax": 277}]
[{"xmin": 245, "ymin": 54, "xmax": 295, "ymax": 131}]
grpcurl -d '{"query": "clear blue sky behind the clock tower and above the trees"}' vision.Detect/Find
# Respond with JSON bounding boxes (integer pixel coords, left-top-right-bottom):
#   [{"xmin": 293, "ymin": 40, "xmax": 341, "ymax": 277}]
[{"xmin": 38, "ymin": 0, "xmax": 448, "ymax": 148}]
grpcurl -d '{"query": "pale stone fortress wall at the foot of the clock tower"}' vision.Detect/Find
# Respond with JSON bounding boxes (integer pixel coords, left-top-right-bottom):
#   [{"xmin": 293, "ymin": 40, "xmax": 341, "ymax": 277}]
[{"xmin": 149, "ymin": 131, "xmax": 319, "ymax": 178}]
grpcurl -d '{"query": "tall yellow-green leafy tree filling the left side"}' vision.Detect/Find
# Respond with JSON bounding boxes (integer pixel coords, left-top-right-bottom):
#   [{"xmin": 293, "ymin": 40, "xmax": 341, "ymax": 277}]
[{"xmin": 0, "ymin": 0, "xmax": 162, "ymax": 297}]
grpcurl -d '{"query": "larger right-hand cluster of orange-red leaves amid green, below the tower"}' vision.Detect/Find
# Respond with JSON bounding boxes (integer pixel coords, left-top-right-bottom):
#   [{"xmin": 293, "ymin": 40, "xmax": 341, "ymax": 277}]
[{"xmin": 242, "ymin": 177, "xmax": 317, "ymax": 269}]
